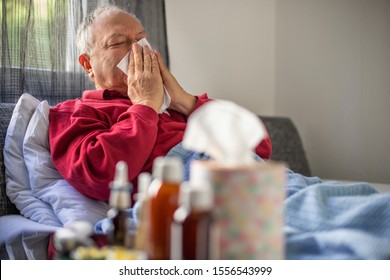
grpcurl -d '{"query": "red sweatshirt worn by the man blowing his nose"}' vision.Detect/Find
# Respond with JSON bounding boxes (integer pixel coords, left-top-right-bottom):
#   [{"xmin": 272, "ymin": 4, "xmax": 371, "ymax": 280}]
[{"xmin": 49, "ymin": 90, "xmax": 272, "ymax": 201}]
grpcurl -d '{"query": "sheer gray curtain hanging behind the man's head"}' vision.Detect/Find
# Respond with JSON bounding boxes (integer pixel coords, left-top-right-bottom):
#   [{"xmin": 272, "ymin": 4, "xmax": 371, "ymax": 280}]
[{"xmin": 0, "ymin": 0, "xmax": 169, "ymax": 105}]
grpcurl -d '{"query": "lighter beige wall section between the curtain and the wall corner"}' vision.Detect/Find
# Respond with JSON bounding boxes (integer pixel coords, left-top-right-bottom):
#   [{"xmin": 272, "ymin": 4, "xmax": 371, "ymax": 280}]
[{"xmin": 165, "ymin": 0, "xmax": 275, "ymax": 114}]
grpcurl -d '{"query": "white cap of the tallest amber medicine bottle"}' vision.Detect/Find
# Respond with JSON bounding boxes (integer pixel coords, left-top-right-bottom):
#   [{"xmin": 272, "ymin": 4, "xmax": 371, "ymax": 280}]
[{"xmin": 153, "ymin": 157, "xmax": 184, "ymax": 183}]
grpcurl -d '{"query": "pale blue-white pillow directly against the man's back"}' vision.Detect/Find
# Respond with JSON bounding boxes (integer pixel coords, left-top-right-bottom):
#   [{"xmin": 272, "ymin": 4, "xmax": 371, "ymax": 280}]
[{"xmin": 23, "ymin": 101, "xmax": 109, "ymax": 225}]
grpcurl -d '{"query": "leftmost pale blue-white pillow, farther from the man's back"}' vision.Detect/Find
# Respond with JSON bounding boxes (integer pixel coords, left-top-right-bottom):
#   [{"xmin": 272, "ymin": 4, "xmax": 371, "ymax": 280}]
[{"xmin": 3, "ymin": 93, "xmax": 61, "ymax": 226}]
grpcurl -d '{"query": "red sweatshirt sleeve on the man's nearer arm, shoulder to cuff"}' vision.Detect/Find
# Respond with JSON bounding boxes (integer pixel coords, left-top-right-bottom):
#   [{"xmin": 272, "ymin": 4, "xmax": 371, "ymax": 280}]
[{"xmin": 49, "ymin": 101, "xmax": 158, "ymax": 201}]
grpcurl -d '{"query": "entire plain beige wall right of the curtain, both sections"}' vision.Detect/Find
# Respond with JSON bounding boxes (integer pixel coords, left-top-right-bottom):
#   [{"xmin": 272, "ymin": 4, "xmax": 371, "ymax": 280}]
[{"xmin": 165, "ymin": 0, "xmax": 390, "ymax": 183}]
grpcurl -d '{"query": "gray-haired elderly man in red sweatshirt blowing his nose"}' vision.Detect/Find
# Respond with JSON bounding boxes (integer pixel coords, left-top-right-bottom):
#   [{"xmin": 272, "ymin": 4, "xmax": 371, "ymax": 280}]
[{"xmin": 49, "ymin": 5, "xmax": 271, "ymax": 201}]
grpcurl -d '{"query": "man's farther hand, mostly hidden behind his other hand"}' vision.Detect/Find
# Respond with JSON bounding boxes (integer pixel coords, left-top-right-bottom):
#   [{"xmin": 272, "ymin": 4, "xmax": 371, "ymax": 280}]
[{"xmin": 157, "ymin": 52, "xmax": 196, "ymax": 116}]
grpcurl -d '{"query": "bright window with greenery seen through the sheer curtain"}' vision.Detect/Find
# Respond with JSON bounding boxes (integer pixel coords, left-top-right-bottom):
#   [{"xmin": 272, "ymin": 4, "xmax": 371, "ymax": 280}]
[{"xmin": 0, "ymin": 0, "xmax": 71, "ymax": 70}]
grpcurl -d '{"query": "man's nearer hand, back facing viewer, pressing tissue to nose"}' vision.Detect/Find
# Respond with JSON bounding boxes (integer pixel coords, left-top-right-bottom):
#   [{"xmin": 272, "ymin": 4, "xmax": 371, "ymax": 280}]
[{"xmin": 127, "ymin": 44, "xmax": 164, "ymax": 112}]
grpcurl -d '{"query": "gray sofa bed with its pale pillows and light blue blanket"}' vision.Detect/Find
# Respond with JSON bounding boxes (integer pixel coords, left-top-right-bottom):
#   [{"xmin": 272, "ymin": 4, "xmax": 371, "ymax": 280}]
[{"xmin": 0, "ymin": 94, "xmax": 390, "ymax": 259}]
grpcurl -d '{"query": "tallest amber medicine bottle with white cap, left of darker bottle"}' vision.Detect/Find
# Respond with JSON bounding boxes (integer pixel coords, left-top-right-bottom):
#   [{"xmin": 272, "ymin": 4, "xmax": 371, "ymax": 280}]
[{"xmin": 147, "ymin": 157, "xmax": 184, "ymax": 260}]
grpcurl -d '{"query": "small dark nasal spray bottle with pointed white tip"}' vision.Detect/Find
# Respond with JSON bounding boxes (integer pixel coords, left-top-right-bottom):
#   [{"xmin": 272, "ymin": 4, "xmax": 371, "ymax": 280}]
[{"xmin": 107, "ymin": 161, "xmax": 134, "ymax": 248}]
